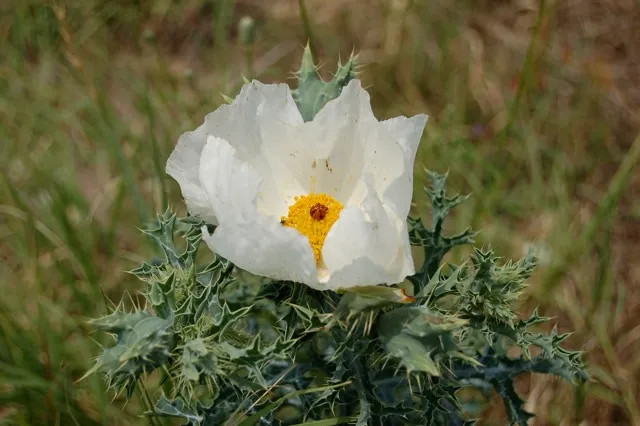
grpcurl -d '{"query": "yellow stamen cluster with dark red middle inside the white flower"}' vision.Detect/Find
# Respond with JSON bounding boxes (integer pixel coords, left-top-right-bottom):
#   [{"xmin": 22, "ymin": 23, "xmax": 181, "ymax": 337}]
[{"xmin": 280, "ymin": 193, "xmax": 343, "ymax": 263}]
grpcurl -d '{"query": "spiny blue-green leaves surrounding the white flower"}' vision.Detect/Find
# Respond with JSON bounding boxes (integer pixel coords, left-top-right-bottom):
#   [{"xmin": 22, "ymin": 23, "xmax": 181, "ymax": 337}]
[{"xmin": 91, "ymin": 49, "xmax": 587, "ymax": 426}]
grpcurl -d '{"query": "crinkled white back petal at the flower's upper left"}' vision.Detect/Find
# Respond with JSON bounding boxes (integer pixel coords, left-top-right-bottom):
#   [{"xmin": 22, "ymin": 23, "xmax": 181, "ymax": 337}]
[{"xmin": 167, "ymin": 81, "xmax": 303, "ymax": 224}]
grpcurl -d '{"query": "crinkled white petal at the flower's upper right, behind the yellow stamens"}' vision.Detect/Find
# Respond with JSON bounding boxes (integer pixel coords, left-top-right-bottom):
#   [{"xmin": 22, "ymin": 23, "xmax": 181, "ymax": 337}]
[{"xmin": 299, "ymin": 80, "xmax": 427, "ymax": 221}]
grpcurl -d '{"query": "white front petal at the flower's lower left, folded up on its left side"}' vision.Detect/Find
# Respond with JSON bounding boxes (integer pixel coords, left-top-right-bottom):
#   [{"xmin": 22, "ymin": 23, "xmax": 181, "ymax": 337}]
[{"xmin": 200, "ymin": 136, "xmax": 317, "ymax": 283}]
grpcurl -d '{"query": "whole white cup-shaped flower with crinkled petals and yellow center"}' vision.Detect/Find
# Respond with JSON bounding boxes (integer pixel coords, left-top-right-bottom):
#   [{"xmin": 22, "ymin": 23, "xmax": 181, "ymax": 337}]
[{"xmin": 167, "ymin": 80, "xmax": 427, "ymax": 290}]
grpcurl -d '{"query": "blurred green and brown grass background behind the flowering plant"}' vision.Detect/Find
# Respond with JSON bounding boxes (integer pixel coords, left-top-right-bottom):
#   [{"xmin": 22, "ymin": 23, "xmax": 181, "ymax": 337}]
[{"xmin": 0, "ymin": 0, "xmax": 640, "ymax": 425}]
